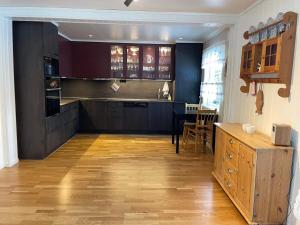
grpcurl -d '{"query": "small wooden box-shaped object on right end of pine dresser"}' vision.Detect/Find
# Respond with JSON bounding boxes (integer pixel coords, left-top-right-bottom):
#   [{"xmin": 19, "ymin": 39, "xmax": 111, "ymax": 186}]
[{"xmin": 272, "ymin": 123, "xmax": 292, "ymax": 146}]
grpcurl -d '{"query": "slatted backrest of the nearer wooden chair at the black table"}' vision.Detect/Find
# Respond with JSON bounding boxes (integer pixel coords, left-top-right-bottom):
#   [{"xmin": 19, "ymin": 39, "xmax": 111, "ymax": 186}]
[{"xmin": 196, "ymin": 109, "xmax": 217, "ymax": 129}]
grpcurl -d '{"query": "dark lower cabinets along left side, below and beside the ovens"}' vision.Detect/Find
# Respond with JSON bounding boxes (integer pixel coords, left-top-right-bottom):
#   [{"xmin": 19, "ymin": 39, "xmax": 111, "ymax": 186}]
[{"xmin": 46, "ymin": 102, "xmax": 79, "ymax": 155}]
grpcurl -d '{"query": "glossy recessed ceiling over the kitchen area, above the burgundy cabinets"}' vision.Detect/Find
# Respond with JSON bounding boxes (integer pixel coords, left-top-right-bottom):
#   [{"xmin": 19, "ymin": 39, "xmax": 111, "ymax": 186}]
[{"xmin": 58, "ymin": 23, "xmax": 223, "ymax": 43}]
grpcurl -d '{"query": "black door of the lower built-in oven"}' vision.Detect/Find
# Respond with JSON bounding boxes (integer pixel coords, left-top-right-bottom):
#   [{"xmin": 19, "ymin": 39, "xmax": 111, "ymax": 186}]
[{"xmin": 46, "ymin": 88, "xmax": 60, "ymax": 117}]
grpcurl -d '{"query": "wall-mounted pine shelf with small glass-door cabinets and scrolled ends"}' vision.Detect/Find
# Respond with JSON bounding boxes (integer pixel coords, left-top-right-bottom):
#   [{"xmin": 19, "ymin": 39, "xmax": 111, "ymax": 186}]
[{"xmin": 240, "ymin": 12, "xmax": 297, "ymax": 98}]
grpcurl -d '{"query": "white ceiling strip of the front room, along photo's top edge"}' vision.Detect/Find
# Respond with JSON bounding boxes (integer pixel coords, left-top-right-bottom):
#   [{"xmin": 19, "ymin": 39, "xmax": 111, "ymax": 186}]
[{"xmin": 0, "ymin": 0, "xmax": 259, "ymax": 14}]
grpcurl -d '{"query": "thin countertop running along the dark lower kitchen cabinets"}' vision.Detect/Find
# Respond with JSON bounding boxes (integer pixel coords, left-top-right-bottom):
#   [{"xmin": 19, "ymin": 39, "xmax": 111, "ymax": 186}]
[{"xmin": 60, "ymin": 97, "xmax": 173, "ymax": 103}]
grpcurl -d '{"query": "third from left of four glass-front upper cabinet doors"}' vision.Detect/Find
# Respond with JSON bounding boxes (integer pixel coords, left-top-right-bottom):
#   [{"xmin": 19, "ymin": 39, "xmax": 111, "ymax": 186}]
[{"xmin": 142, "ymin": 46, "xmax": 156, "ymax": 79}]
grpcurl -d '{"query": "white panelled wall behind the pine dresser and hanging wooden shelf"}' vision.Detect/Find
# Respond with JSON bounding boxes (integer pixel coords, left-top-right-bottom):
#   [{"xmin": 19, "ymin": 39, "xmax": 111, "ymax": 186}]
[{"xmin": 224, "ymin": 0, "xmax": 300, "ymax": 225}]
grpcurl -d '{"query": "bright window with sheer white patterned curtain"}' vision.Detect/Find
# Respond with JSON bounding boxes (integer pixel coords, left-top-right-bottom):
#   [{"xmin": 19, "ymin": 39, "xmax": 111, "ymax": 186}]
[{"xmin": 200, "ymin": 43, "xmax": 226, "ymax": 112}]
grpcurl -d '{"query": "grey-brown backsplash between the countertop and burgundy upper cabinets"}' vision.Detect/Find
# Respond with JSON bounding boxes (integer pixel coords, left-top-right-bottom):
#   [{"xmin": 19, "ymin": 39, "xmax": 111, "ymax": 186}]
[{"xmin": 61, "ymin": 79, "xmax": 173, "ymax": 99}]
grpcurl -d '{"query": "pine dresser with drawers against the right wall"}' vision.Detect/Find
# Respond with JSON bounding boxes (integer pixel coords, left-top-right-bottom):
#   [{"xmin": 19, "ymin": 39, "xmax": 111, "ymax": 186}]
[{"xmin": 213, "ymin": 123, "xmax": 293, "ymax": 224}]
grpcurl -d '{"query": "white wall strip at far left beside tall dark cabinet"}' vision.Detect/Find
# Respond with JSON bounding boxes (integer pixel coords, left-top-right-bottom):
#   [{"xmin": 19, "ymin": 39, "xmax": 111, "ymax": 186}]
[{"xmin": 0, "ymin": 17, "xmax": 18, "ymax": 168}]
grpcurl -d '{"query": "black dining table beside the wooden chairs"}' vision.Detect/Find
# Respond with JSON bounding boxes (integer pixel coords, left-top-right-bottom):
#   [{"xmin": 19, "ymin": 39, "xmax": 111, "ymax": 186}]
[{"xmin": 172, "ymin": 104, "xmax": 218, "ymax": 154}]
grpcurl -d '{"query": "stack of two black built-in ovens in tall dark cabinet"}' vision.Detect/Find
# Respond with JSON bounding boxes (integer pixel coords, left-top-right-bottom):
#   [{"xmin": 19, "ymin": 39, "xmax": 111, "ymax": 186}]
[{"xmin": 44, "ymin": 57, "xmax": 61, "ymax": 117}]
